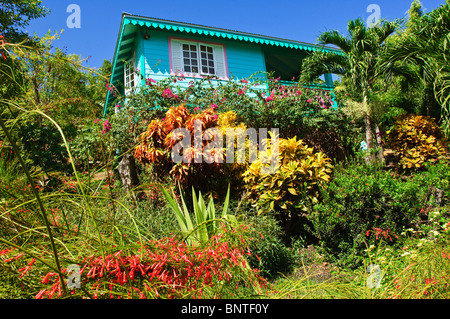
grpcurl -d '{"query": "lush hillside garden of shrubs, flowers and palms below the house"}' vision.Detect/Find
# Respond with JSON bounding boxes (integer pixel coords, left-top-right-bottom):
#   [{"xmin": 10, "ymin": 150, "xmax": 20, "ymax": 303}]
[{"xmin": 0, "ymin": 1, "xmax": 450, "ymax": 299}]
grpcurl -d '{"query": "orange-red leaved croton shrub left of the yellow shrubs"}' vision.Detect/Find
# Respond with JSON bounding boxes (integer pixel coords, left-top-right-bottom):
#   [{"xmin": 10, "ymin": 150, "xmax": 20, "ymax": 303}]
[{"xmin": 134, "ymin": 105, "xmax": 239, "ymax": 195}]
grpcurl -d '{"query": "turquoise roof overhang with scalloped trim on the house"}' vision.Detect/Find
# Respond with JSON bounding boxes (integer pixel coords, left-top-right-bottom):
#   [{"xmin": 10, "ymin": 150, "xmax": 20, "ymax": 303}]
[{"xmin": 104, "ymin": 13, "xmax": 342, "ymax": 115}]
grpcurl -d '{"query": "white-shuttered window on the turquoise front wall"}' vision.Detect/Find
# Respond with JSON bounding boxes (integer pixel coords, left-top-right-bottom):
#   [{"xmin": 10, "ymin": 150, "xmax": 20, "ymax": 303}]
[{"xmin": 171, "ymin": 39, "xmax": 227, "ymax": 78}]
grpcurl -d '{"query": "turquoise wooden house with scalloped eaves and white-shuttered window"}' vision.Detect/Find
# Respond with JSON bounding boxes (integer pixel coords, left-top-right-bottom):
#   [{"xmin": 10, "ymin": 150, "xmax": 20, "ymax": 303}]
[{"xmin": 104, "ymin": 13, "xmax": 337, "ymax": 115}]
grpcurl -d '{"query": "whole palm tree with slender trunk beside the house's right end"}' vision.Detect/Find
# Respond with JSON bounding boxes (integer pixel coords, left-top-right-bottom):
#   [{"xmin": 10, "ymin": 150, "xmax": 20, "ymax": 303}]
[{"xmin": 301, "ymin": 19, "xmax": 409, "ymax": 160}]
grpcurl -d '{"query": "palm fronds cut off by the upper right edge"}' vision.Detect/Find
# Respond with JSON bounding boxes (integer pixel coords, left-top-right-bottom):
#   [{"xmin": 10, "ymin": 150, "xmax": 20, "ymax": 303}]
[{"xmin": 386, "ymin": 0, "xmax": 450, "ymax": 134}]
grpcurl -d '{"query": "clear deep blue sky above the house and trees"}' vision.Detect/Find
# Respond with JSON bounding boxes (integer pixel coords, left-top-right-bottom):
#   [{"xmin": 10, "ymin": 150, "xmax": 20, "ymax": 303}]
[{"xmin": 27, "ymin": 0, "xmax": 445, "ymax": 68}]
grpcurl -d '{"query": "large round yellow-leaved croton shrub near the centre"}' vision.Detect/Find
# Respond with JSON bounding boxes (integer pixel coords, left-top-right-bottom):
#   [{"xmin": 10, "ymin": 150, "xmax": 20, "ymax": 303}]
[{"xmin": 243, "ymin": 137, "xmax": 333, "ymax": 214}]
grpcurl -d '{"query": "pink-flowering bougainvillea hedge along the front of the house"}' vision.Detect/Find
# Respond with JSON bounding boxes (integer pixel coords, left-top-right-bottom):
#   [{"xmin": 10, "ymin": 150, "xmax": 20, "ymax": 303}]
[{"xmin": 102, "ymin": 75, "xmax": 356, "ymax": 169}]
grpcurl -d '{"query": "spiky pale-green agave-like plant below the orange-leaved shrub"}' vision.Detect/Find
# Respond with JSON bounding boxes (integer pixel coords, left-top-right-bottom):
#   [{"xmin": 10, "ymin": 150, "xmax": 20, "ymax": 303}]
[{"xmin": 161, "ymin": 186, "xmax": 237, "ymax": 245}]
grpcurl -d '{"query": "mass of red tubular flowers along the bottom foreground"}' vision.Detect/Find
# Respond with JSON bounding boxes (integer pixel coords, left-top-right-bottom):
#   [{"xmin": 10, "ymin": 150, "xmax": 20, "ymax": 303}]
[{"xmin": 32, "ymin": 229, "xmax": 265, "ymax": 299}]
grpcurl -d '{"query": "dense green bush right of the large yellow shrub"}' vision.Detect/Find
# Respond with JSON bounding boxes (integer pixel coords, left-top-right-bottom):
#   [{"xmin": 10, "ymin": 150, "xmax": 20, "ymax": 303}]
[{"xmin": 310, "ymin": 164, "xmax": 428, "ymax": 267}]
